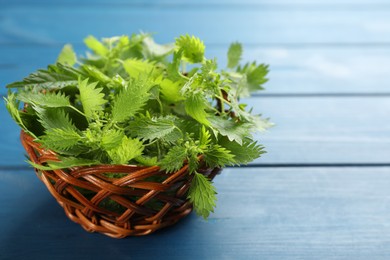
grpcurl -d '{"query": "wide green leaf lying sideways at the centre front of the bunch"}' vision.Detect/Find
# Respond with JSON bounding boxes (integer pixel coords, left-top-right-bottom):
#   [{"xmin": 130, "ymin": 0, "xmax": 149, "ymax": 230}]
[{"xmin": 127, "ymin": 115, "xmax": 183, "ymax": 142}]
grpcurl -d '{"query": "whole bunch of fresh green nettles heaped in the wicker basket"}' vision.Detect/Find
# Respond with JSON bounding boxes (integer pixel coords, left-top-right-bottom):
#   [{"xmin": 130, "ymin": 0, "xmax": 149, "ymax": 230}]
[{"xmin": 6, "ymin": 34, "xmax": 270, "ymax": 218}]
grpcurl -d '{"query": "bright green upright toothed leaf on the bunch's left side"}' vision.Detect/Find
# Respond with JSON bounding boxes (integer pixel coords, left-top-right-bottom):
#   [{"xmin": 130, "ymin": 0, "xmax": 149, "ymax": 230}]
[{"xmin": 79, "ymin": 79, "xmax": 107, "ymax": 118}]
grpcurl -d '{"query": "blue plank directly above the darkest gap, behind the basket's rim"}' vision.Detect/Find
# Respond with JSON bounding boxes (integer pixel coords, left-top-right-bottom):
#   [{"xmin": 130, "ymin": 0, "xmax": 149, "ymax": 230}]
[{"xmin": 0, "ymin": 97, "xmax": 390, "ymax": 166}]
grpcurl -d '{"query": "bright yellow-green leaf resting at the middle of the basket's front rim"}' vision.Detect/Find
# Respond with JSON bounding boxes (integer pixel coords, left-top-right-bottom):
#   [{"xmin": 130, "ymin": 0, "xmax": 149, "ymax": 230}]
[{"xmin": 108, "ymin": 136, "xmax": 144, "ymax": 164}]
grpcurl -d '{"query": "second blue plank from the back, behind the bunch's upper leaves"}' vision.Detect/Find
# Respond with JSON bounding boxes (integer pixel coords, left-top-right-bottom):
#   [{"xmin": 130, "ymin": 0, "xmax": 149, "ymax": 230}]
[{"xmin": 0, "ymin": 44, "xmax": 390, "ymax": 94}]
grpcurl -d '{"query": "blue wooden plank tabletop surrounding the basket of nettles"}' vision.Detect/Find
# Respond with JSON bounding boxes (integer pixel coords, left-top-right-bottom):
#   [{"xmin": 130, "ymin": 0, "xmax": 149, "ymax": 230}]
[{"xmin": 0, "ymin": 0, "xmax": 390, "ymax": 259}]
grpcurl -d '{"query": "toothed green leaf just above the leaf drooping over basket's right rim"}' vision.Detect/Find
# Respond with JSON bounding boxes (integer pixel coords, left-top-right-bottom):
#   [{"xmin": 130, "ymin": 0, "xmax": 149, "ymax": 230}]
[{"xmin": 204, "ymin": 144, "xmax": 236, "ymax": 167}]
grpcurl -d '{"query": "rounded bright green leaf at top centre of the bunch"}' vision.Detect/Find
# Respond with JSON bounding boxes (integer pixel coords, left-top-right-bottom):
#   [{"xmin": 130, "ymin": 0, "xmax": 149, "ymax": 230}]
[{"xmin": 175, "ymin": 34, "xmax": 205, "ymax": 63}]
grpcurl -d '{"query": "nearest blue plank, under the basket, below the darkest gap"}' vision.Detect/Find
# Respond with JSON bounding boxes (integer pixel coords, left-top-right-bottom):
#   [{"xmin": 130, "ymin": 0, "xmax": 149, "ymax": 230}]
[{"xmin": 0, "ymin": 167, "xmax": 390, "ymax": 259}]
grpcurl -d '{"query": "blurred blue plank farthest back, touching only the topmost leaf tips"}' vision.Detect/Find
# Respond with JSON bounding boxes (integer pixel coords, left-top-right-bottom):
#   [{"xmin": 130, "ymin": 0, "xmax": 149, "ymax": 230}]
[{"xmin": 0, "ymin": 5, "xmax": 390, "ymax": 45}]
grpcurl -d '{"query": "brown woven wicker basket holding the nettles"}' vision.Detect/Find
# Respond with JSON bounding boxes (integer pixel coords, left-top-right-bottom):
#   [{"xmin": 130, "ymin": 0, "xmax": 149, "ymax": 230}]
[{"xmin": 21, "ymin": 131, "xmax": 221, "ymax": 238}]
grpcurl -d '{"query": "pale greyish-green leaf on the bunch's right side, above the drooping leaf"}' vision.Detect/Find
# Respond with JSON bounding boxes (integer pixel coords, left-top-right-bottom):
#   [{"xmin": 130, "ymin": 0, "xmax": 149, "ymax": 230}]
[{"xmin": 209, "ymin": 116, "xmax": 253, "ymax": 144}]
